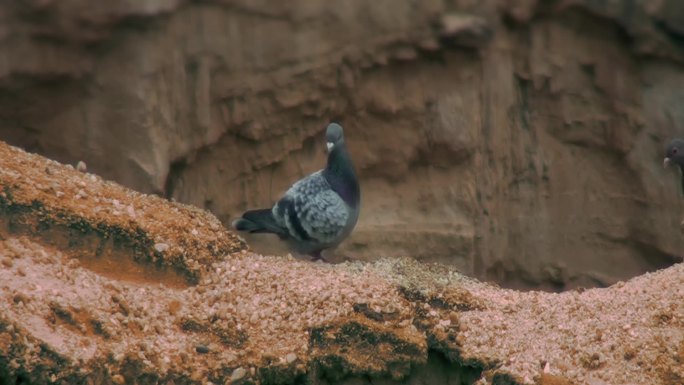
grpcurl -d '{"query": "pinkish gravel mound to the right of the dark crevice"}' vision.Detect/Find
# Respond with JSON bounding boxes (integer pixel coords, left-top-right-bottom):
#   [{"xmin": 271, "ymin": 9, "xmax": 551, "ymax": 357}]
[{"xmin": 346, "ymin": 258, "xmax": 684, "ymax": 385}]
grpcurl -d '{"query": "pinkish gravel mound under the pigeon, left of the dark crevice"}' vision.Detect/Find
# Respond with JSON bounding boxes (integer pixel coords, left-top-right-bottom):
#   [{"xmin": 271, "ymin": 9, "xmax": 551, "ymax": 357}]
[{"xmin": 0, "ymin": 232, "xmax": 427, "ymax": 381}]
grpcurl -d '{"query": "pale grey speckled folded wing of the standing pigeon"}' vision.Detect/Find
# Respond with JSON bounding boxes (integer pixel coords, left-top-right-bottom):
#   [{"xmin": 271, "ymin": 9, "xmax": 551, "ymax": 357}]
[{"xmin": 273, "ymin": 171, "xmax": 349, "ymax": 244}]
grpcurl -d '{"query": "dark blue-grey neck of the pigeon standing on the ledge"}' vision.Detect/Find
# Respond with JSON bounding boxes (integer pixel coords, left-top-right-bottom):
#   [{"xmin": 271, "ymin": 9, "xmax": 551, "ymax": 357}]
[{"xmin": 323, "ymin": 143, "xmax": 361, "ymax": 207}]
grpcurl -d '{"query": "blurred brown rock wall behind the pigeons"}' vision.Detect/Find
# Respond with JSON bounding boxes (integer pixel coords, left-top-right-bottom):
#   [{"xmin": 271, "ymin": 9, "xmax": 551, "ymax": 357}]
[{"xmin": 0, "ymin": 0, "xmax": 684, "ymax": 290}]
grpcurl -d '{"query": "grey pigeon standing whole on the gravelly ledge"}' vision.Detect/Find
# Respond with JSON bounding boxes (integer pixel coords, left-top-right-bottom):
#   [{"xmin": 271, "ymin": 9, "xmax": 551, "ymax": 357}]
[{"xmin": 233, "ymin": 123, "xmax": 361, "ymax": 261}]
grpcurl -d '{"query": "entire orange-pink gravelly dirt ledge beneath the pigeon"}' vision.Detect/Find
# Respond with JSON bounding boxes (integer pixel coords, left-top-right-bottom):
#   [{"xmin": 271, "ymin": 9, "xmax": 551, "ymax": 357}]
[{"xmin": 0, "ymin": 140, "xmax": 684, "ymax": 385}]
